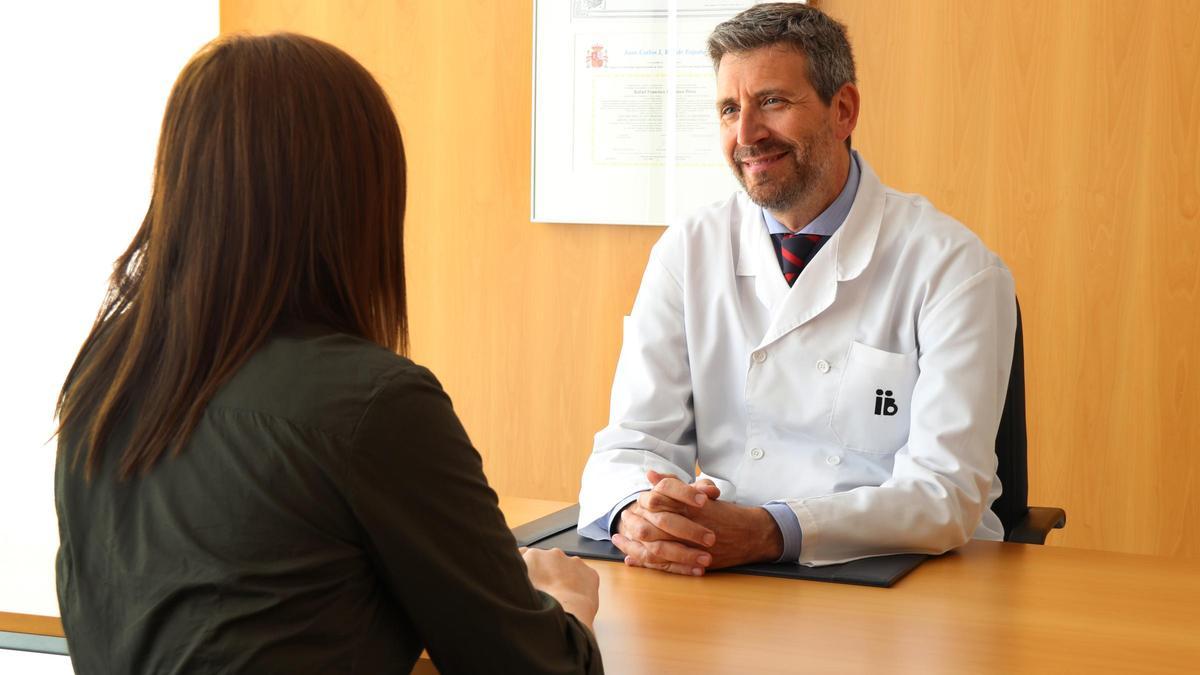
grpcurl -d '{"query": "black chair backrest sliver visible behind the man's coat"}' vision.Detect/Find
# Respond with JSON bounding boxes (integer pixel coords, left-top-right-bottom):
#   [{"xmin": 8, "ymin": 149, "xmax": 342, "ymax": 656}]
[{"xmin": 991, "ymin": 297, "xmax": 1030, "ymax": 539}]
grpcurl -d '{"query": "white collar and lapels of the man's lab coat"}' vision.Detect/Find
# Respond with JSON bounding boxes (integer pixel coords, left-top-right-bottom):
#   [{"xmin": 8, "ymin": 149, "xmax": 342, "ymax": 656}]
[{"xmin": 734, "ymin": 150, "xmax": 883, "ymax": 347}]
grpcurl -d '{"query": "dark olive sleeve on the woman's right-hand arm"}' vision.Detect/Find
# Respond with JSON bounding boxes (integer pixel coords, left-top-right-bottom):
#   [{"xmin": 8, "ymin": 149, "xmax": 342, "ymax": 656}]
[{"xmin": 347, "ymin": 365, "xmax": 602, "ymax": 674}]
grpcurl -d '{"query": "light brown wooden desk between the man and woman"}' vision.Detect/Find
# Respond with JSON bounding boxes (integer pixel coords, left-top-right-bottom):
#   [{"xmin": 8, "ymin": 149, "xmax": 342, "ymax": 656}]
[{"xmin": 0, "ymin": 498, "xmax": 1200, "ymax": 675}]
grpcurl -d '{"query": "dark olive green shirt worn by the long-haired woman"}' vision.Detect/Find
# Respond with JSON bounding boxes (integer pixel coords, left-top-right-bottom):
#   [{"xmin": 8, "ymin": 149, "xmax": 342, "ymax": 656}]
[{"xmin": 55, "ymin": 327, "xmax": 602, "ymax": 674}]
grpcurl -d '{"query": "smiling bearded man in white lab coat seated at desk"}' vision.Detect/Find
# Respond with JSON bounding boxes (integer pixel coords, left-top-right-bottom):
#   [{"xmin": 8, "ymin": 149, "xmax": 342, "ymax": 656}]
[{"xmin": 580, "ymin": 2, "xmax": 1016, "ymax": 575}]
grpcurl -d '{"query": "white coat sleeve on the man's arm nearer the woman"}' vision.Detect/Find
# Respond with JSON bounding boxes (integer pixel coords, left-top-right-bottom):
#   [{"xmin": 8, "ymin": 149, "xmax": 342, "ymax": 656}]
[{"xmin": 580, "ymin": 235, "xmax": 696, "ymax": 539}]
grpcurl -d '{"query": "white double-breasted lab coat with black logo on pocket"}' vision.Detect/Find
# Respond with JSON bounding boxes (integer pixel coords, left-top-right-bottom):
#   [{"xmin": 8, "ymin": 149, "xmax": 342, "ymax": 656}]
[{"xmin": 580, "ymin": 160, "xmax": 1016, "ymax": 565}]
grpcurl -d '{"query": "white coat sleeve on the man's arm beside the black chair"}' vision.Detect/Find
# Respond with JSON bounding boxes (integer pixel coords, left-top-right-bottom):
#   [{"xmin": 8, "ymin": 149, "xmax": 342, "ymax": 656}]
[{"xmin": 787, "ymin": 267, "xmax": 1016, "ymax": 565}]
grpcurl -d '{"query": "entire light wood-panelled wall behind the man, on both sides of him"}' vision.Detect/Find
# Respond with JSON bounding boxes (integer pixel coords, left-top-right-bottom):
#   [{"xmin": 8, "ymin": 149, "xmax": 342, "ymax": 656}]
[{"xmin": 221, "ymin": 0, "xmax": 1200, "ymax": 556}]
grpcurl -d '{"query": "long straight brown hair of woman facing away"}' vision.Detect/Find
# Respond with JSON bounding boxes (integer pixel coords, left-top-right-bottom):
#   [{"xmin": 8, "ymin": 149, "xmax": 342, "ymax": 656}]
[{"xmin": 58, "ymin": 34, "xmax": 408, "ymax": 479}]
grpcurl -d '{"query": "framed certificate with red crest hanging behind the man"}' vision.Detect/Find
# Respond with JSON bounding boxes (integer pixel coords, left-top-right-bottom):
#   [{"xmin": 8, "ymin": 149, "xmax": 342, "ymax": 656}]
[{"xmin": 530, "ymin": 0, "xmax": 772, "ymax": 225}]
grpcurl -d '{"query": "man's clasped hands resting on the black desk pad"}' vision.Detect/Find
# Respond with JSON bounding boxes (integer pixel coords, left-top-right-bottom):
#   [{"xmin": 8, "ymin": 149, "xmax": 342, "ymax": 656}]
[{"xmin": 612, "ymin": 471, "xmax": 784, "ymax": 577}]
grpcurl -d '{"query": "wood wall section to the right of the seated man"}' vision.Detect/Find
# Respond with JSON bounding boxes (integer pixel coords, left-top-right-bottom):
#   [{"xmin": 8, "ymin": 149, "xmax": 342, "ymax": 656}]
[{"xmin": 822, "ymin": 0, "xmax": 1200, "ymax": 556}]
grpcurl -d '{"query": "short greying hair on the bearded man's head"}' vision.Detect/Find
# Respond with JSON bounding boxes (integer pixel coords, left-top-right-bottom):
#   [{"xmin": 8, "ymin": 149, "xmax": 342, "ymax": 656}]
[{"xmin": 708, "ymin": 2, "xmax": 857, "ymax": 106}]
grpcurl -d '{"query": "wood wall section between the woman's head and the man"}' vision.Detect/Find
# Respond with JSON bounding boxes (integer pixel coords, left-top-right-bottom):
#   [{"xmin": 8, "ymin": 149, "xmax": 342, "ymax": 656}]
[{"xmin": 221, "ymin": 0, "xmax": 661, "ymax": 501}]
